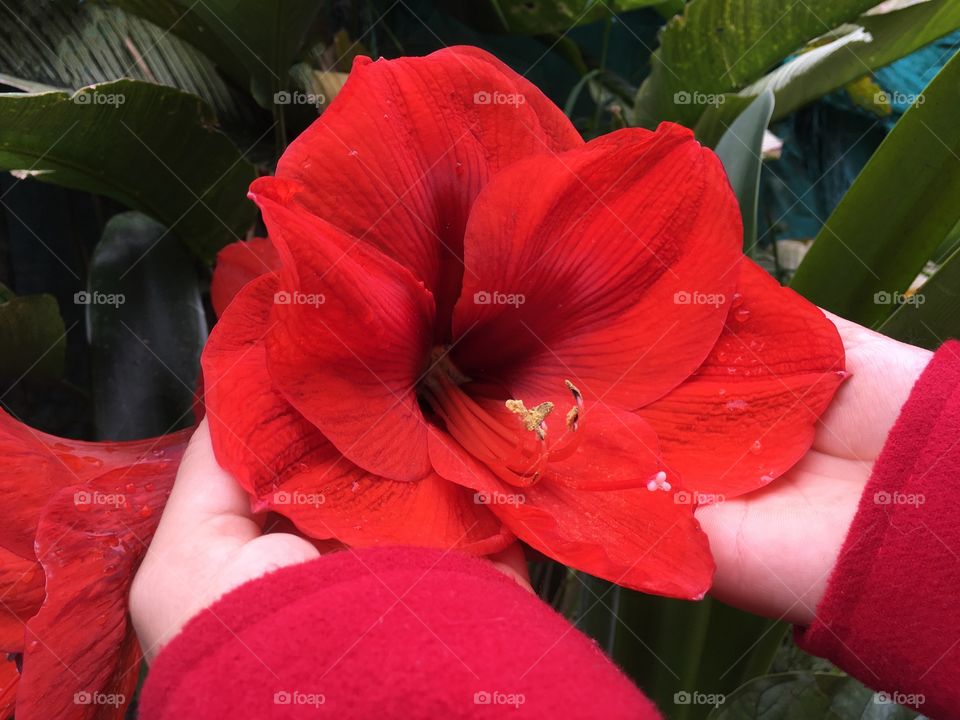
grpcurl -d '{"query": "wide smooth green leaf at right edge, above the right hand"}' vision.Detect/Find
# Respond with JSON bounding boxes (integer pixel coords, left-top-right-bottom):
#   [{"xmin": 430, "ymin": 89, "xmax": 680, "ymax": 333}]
[{"xmin": 791, "ymin": 55, "xmax": 960, "ymax": 326}]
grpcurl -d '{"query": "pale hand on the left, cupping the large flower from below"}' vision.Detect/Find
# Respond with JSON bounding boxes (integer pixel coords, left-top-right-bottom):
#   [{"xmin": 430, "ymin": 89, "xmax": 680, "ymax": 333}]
[{"xmin": 130, "ymin": 421, "xmax": 530, "ymax": 662}]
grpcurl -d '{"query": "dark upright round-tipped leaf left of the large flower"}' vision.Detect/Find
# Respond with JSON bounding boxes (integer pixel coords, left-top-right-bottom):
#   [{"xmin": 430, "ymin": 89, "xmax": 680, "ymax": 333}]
[{"xmin": 86, "ymin": 212, "xmax": 207, "ymax": 440}]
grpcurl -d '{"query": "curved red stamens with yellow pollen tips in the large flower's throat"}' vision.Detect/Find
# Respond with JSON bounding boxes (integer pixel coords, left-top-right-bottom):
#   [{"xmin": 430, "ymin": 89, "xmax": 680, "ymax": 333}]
[{"xmin": 420, "ymin": 348, "xmax": 583, "ymax": 487}]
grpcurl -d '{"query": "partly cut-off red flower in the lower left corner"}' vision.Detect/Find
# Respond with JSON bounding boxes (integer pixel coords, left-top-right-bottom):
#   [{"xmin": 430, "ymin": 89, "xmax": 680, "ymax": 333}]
[{"xmin": 0, "ymin": 412, "xmax": 189, "ymax": 720}]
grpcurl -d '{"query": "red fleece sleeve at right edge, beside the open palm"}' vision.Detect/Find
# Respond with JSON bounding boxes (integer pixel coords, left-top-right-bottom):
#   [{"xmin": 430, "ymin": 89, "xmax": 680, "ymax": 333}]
[{"xmin": 796, "ymin": 341, "xmax": 960, "ymax": 718}]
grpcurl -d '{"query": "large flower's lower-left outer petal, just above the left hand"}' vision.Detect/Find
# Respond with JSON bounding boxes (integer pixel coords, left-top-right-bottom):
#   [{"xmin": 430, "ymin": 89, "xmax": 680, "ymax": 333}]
[{"xmin": 203, "ymin": 276, "xmax": 511, "ymax": 554}]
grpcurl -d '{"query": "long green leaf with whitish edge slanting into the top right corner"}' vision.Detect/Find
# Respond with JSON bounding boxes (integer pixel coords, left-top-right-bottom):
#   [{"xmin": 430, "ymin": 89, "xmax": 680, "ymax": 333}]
[{"xmin": 697, "ymin": 0, "xmax": 960, "ymax": 138}]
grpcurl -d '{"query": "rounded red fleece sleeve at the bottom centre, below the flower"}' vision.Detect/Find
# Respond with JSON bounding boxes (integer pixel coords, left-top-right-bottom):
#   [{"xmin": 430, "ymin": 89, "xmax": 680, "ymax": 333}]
[{"xmin": 140, "ymin": 548, "xmax": 659, "ymax": 720}]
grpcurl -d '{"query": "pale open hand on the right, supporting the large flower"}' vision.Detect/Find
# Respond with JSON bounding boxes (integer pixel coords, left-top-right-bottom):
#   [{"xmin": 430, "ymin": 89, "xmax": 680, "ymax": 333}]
[{"xmin": 696, "ymin": 313, "xmax": 931, "ymax": 625}]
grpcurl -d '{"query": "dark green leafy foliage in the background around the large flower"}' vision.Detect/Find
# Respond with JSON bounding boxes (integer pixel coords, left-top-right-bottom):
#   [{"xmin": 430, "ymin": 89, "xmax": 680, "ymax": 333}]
[{"xmin": 0, "ymin": 0, "xmax": 960, "ymax": 720}]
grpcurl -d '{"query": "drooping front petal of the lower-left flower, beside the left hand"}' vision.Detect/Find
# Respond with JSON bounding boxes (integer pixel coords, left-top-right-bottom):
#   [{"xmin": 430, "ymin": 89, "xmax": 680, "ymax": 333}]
[{"xmin": 17, "ymin": 456, "xmax": 188, "ymax": 720}]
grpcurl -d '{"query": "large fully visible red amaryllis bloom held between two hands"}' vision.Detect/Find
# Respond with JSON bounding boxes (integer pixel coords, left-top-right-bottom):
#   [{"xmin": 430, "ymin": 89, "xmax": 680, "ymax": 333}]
[{"xmin": 203, "ymin": 43, "xmax": 843, "ymax": 597}]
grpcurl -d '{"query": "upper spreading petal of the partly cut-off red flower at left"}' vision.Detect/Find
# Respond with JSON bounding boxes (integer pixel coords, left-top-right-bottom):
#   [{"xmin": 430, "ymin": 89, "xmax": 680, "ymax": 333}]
[{"xmin": 0, "ymin": 411, "xmax": 186, "ymax": 558}]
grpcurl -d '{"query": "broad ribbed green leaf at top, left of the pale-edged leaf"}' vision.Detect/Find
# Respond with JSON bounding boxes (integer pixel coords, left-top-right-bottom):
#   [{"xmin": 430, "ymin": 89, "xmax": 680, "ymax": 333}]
[{"xmin": 635, "ymin": 0, "xmax": 876, "ymax": 127}]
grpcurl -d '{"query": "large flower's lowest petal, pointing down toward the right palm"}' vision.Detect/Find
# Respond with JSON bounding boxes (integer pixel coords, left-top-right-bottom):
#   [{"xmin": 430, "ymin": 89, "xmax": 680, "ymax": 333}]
[{"xmin": 430, "ymin": 433, "xmax": 714, "ymax": 599}]
